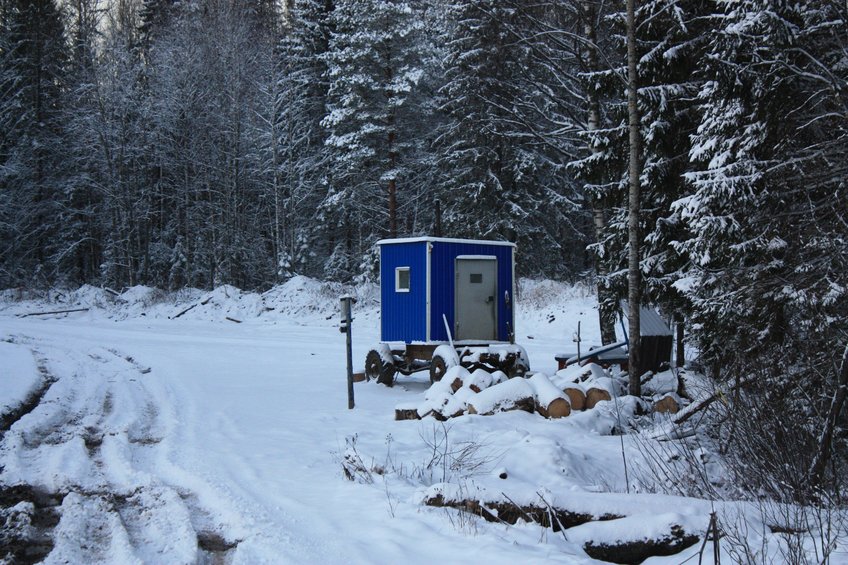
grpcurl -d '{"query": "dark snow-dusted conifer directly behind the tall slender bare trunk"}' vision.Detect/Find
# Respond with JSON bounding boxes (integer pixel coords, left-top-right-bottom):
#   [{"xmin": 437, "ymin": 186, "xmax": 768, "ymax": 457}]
[{"xmin": 574, "ymin": 0, "xmax": 711, "ymax": 352}]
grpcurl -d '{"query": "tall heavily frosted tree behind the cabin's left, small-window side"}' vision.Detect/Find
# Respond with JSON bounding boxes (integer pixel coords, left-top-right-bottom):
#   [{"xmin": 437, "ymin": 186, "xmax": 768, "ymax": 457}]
[{"xmin": 322, "ymin": 0, "xmax": 424, "ymax": 277}]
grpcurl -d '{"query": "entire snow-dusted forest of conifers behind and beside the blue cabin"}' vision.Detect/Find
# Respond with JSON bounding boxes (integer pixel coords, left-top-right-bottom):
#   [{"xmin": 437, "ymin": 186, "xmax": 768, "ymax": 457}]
[{"xmin": 0, "ymin": 0, "xmax": 848, "ymax": 500}]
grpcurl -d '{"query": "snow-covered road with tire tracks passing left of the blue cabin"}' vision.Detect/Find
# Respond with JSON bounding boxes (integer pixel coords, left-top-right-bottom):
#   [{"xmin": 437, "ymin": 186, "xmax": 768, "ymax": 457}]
[{"xmin": 0, "ymin": 318, "xmax": 588, "ymax": 563}]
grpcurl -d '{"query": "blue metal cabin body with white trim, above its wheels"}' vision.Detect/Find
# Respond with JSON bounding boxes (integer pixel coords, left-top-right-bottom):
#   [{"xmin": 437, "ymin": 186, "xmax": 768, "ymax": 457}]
[{"xmin": 377, "ymin": 237, "xmax": 515, "ymax": 344}]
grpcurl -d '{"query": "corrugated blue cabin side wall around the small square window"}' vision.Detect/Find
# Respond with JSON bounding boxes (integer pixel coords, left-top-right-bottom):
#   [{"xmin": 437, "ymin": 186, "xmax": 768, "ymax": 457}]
[{"xmin": 380, "ymin": 241, "xmax": 427, "ymax": 343}]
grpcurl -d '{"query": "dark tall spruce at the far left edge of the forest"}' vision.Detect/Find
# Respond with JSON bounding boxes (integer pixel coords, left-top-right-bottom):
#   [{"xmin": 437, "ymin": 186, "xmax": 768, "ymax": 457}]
[{"xmin": 0, "ymin": 0, "xmax": 67, "ymax": 285}]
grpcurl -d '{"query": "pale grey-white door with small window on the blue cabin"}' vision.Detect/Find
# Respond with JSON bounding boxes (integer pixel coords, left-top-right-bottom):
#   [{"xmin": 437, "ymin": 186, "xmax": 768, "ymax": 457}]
[{"xmin": 454, "ymin": 257, "xmax": 498, "ymax": 341}]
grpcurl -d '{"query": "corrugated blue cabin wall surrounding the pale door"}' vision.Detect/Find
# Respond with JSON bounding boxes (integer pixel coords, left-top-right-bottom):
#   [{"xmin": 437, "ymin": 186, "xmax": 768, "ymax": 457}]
[{"xmin": 430, "ymin": 241, "xmax": 515, "ymax": 341}]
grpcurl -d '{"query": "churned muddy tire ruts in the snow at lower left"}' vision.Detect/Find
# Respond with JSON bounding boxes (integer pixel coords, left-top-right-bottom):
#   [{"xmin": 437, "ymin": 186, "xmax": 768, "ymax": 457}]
[{"xmin": 0, "ymin": 338, "xmax": 238, "ymax": 563}]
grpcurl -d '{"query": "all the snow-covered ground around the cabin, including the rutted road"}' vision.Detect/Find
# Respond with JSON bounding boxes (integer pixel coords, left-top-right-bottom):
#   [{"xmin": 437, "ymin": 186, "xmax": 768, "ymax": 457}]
[{"xmin": 0, "ymin": 278, "xmax": 848, "ymax": 564}]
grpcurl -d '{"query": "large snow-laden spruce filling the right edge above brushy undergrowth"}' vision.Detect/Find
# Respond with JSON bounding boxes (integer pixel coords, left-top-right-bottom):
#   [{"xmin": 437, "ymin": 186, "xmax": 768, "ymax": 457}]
[{"xmin": 674, "ymin": 0, "xmax": 848, "ymax": 501}]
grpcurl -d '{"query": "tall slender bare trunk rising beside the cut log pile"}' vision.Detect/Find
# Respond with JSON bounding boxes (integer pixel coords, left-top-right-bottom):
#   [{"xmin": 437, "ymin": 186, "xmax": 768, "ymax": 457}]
[{"xmin": 627, "ymin": 0, "xmax": 642, "ymax": 396}]
